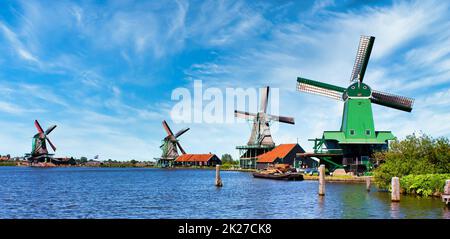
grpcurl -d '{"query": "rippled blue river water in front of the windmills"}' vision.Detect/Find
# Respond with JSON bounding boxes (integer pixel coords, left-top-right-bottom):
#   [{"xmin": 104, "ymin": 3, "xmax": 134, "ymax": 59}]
[{"xmin": 0, "ymin": 167, "xmax": 450, "ymax": 219}]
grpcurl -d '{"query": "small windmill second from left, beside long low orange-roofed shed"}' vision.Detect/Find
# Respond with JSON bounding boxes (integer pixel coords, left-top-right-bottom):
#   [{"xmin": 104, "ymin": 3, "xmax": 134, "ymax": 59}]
[{"xmin": 158, "ymin": 120, "xmax": 189, "ymax": 167}]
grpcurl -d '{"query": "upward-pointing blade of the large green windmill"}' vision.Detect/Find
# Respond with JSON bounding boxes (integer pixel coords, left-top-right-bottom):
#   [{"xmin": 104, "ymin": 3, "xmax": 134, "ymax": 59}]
[{"xmin": 350, "ymin": 36, "xmax": 375, "ymax": 82}]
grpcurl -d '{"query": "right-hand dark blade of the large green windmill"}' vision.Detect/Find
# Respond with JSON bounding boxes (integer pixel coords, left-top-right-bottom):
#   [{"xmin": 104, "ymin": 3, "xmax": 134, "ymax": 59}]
[{"xmin": 370, "ymin": 91, "xmax": 414, "ymax": 112}]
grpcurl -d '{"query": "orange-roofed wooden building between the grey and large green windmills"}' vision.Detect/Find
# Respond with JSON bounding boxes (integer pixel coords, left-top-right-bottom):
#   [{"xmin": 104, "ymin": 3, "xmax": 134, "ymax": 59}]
[{"xmin": 256, "ymin": 144, "xmax": 305, "ymax": 169}]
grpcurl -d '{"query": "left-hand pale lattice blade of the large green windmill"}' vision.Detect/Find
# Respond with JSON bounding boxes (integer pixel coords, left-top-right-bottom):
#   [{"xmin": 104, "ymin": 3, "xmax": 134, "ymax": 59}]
[{"xmin": 297, "ymin": 77, "xmax": 346, "ymax": 100}]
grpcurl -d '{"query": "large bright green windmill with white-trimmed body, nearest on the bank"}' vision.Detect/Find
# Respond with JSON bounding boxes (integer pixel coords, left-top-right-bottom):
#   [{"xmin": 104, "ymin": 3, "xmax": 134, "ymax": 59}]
[{"xmin": 297, "ymin": 36, "xmax": 414, "ymax": 173}]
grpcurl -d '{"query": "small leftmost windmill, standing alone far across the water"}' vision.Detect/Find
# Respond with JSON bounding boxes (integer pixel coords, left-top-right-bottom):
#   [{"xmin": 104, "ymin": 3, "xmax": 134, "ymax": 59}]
[{"xmin": 26, "ymin": 120, "xmax": 56, "ymax": 162}]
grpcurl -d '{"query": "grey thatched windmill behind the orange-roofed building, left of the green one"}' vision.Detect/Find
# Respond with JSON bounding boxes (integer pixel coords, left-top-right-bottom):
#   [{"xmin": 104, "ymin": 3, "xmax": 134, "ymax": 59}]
[{"xmin": 234, "ymin": 86, "xmax": 295, "ymax": 168}]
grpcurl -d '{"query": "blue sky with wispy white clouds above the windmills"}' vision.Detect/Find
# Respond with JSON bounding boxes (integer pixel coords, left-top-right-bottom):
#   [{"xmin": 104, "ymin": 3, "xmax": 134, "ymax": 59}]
[{"xmin": 0, "ymin": 0, "xmax": 450, "ymax": 160}]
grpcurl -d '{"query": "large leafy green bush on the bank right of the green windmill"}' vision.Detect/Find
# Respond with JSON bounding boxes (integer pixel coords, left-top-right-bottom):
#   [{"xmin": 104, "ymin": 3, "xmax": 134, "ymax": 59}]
[{"xmin": 374, "ymin": 134, "xmax": 450, "ymax": 189}]
